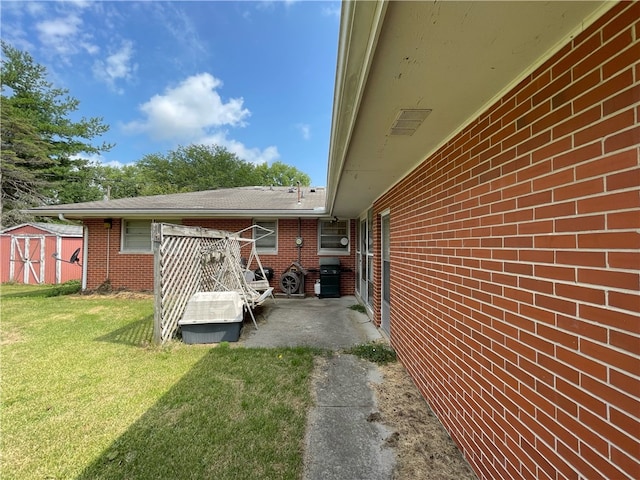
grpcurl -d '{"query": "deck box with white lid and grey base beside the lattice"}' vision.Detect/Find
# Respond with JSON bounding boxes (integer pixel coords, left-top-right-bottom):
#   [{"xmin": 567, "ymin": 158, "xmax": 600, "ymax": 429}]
[{"xmin": 178, "ymin": 292, "xmax": 243, "ymax": 344}]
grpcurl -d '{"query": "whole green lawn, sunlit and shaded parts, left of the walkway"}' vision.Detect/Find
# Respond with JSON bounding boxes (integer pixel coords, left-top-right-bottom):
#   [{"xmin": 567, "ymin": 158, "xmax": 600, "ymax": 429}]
[{"xmin": 0, "ymin": 285, "xmax": 315, "ymax": 480}]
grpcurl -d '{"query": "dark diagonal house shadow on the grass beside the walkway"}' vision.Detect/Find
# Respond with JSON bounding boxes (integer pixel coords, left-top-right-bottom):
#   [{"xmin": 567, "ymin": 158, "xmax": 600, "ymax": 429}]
[{"xmin": 76, "ymin": 345, "xmax": 313, "ymax": 480}]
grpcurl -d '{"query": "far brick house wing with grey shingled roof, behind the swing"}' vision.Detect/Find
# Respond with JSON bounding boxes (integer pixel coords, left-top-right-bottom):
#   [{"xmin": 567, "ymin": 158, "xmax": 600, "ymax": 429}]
[{"xmin": 28, "ymin": 187, "xmax": 355, "ymax": 295}]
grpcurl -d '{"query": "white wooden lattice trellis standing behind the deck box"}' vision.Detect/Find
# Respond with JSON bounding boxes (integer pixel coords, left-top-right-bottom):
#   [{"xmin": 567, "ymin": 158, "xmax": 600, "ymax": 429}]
[{"xmin": 152, "ymin": 223, "xmax": 273, "ymax": 343}]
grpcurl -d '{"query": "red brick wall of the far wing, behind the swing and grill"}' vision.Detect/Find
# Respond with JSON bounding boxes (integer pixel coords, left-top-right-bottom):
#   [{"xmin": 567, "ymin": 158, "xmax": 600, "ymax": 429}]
[{"xmin": 85, "ymin": 218, "xmax": 355, "ymax": 295}]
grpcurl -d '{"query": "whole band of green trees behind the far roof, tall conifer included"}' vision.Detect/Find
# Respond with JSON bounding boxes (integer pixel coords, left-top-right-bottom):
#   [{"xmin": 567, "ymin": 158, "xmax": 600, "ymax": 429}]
[{"xmin": 0, "ymin": 42, "xmax": 311, "ymax": 227}]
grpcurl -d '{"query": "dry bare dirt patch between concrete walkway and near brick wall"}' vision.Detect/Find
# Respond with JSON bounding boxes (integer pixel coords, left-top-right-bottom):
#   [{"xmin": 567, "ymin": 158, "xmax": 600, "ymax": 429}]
[{"xmin": 371, "ymin": 362, "xmax": 477, "ymax": 480}]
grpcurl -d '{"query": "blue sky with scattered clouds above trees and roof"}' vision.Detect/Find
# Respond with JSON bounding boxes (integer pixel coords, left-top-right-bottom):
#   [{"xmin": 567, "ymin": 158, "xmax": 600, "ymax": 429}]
[{"xmin": 0, "ymin": 1, "xmax": 340, "ymax": 185}]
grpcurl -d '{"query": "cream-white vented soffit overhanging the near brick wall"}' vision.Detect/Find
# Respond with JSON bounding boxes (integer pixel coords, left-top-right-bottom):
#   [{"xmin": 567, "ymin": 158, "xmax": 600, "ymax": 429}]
[{"xmin": 327, "ymin": 1, "xmax": 615, "ymax": 218}]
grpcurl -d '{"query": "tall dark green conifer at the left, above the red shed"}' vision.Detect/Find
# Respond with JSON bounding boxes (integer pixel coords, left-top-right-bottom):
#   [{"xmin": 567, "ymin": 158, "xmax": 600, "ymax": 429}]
[{"xmin": 0, "ymin": 42, "xmax": 111, "ymax": 225}]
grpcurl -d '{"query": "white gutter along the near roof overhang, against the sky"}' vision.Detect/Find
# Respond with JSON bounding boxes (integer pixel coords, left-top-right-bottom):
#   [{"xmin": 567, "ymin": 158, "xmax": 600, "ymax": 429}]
[{"xmin": 326, "ymin": 0, "xmax": 388, "ymax": 215}]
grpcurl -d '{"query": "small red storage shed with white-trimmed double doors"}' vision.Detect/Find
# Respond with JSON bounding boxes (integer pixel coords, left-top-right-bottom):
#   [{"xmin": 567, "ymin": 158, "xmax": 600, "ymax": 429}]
[{"xmin": 0, "ymin": 223, "xmax": 82, "ymax": 285}]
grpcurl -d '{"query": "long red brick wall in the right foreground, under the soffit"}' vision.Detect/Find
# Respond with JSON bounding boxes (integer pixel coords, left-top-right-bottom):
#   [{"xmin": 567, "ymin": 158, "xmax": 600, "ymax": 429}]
[{"xmin": 374, "ymin": 3, "xmax": 640, "ymax": 479}]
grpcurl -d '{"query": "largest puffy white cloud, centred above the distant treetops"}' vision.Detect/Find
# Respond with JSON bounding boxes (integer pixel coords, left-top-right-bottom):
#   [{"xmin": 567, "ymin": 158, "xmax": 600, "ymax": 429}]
[{"xmin": 124, "ymin": 73, "xmax": 251, "ymax": 142}]
